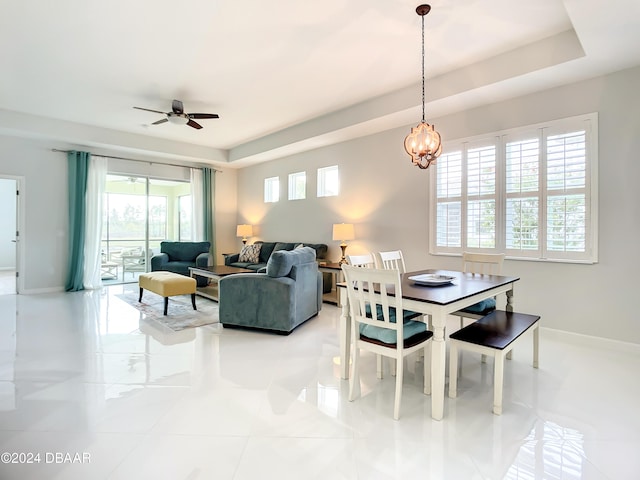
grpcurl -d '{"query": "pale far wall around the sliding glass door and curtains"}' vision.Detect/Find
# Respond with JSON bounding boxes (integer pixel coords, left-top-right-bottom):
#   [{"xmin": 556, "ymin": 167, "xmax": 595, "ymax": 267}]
[{"xmin": 0, "ymin": 135, "xmax": 236, "ymax": 293}]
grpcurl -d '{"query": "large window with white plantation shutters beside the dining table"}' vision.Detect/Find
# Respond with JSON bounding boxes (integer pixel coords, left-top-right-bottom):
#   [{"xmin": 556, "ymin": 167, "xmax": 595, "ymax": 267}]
[{"xmin": 430, "ymin": 114, "xmax": 597, "ymax": 262}]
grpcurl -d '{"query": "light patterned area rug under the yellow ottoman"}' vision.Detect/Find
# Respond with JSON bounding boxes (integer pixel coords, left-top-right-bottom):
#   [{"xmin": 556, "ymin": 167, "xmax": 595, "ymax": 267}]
[{"xmin": 116, "ymin": 290, "xmax": 220, "ymax": 332}]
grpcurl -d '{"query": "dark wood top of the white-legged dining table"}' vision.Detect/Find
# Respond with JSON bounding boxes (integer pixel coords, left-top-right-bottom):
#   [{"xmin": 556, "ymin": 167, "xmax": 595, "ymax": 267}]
[{"xmin": 338, "ymin": 269, "xmax": 520, "ymax": 305}]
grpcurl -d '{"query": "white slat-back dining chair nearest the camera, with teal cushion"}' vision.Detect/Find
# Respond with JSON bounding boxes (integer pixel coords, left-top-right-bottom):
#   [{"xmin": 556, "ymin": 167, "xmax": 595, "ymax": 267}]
[{"xmin": 342, "ymin": 265, "xmax": 433, "ymax": 420}]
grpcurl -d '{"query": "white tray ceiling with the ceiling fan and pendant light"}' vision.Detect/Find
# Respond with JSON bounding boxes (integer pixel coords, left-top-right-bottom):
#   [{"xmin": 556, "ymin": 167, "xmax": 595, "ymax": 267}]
[{"xmin": 0, "ymin": 0, "xmax": 640, "ymax": 166}]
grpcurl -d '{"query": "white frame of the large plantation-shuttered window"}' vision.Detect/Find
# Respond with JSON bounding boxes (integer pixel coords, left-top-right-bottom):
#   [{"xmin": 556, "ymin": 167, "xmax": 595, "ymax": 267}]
[{"xmin": 429, "ymin": 113, "xmax": 598, "ymax": 264}]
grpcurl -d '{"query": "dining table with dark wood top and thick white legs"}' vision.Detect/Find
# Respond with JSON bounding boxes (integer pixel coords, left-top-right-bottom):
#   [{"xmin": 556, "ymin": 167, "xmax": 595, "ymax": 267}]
[{"xmin": 337, "ymin": 269, "xmax": 520, "ymax": 420}]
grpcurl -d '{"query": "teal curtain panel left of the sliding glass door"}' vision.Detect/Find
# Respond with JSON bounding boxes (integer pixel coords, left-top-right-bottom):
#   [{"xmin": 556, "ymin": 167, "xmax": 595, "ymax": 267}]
[{"xmin": 65, "ymin": 151, "xmax": 91, "ymax": 292}]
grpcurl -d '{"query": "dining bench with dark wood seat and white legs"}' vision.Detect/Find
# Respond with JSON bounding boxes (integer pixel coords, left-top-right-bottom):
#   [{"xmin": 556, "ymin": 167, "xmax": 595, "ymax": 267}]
[{"xmin": 449, "ymin": 310, "xmax": 540, "ymax": 415}]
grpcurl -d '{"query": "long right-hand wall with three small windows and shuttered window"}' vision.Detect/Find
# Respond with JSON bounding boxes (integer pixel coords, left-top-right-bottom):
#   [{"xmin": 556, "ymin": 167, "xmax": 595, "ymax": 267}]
[{"xmin": 238, "ymin": 68, "xmax": 640, "ymax": 343}]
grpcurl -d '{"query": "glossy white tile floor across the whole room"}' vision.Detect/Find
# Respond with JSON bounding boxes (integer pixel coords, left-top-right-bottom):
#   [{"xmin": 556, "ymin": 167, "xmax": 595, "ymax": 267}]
[{"xmin": 0, "ymin": 285, "xmax": 640, "ymax": 480}]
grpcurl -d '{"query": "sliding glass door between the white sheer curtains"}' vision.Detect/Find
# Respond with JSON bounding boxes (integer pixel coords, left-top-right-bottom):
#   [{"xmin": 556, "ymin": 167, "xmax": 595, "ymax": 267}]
[{"xmin": 102, "ymin": 174, "xmax": 192, "ymax": 284}]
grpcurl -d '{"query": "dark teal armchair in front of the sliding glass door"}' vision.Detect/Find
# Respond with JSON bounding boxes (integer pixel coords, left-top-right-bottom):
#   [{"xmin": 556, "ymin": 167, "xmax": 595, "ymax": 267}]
[{"xmin": 151, "ymin": 241, "xmax": 211, "ymax": 287}]
